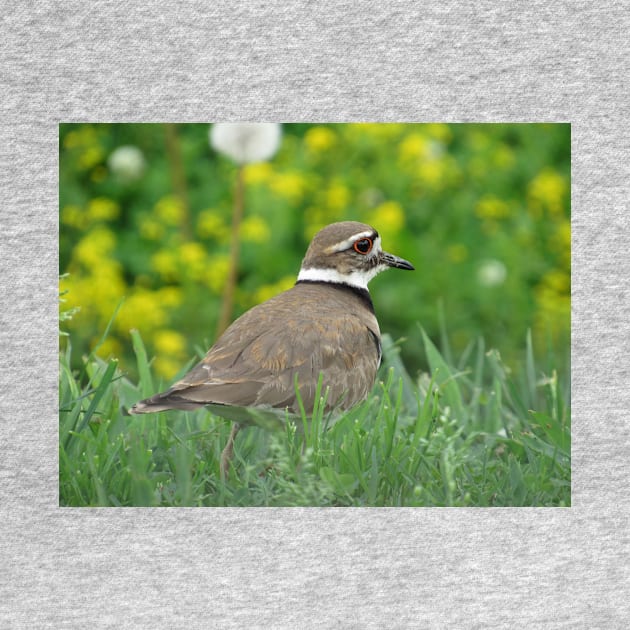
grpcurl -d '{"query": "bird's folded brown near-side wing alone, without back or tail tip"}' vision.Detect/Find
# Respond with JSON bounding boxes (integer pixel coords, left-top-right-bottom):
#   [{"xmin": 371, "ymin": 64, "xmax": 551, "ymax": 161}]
[{"xmin": 162, "ymin": 316, "xmax": 379, "ymax": 413}]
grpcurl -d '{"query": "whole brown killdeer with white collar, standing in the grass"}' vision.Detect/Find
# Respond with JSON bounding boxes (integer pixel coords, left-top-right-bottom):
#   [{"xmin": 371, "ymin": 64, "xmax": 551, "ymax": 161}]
[{"xmin": 129, "ymin": 221, "xmax": 414, "ymax": 475}]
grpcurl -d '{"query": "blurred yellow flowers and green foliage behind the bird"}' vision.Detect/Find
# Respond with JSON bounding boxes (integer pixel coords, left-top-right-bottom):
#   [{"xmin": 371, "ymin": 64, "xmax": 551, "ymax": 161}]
[{"xmin": 59, "ymin": 123, "xmax": 571, "ymax": 383}]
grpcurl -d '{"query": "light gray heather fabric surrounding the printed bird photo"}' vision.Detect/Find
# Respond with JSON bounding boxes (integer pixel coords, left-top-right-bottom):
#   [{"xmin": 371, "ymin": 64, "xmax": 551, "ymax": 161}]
[{"xmin": 0, "ymin": 0, "xmax": 630, "ymax": 628}]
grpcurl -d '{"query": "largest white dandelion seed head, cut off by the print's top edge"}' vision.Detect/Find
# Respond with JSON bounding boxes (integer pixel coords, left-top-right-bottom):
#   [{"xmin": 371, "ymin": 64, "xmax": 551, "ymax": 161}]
[{"xmin": 210, "ymin": 123, "xmax": 282, "ymax": 164}]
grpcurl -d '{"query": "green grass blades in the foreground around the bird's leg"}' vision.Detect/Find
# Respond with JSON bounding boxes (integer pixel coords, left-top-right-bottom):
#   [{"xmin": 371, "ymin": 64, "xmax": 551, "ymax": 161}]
[{"xmin": 59, "ymin": 331, "xmax": 571, "ymax": 506}]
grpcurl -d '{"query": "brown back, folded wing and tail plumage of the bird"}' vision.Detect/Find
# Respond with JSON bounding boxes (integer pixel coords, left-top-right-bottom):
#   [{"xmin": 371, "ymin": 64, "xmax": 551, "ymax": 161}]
[{"xmin": 132, "ymin": 285, "xmax": 380, "ymax": 413}]
